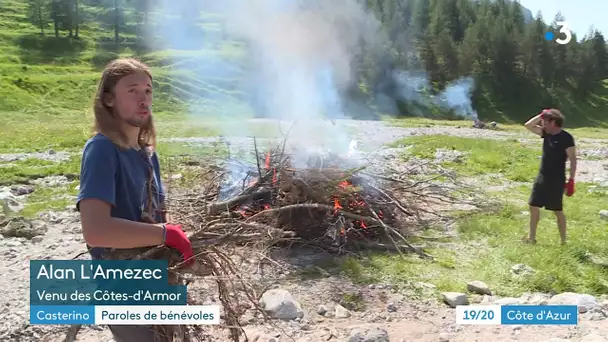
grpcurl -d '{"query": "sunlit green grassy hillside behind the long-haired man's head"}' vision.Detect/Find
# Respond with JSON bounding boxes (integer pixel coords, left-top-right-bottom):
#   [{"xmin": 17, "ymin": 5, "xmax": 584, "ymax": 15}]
[{"xmin": 0, "ymin": 0, "xmax": 256, "ymax": 152}]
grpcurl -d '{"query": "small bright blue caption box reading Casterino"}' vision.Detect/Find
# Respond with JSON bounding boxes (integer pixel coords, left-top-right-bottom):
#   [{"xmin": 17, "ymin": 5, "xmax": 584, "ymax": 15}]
[{"xmin": 30, "ymin": 305, "xmax": 95, "ymax": 324}]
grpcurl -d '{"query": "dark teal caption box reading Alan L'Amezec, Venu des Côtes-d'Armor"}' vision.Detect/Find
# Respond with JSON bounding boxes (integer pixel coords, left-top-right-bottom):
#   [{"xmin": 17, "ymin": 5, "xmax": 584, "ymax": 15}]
[{"xmin": 30, "ymin": 260, "xmax": 187, "ymax": 306}]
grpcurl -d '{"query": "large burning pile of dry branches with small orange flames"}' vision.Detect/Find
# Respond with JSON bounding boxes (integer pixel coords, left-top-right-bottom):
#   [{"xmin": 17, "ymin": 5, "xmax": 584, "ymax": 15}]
[{"xmin": 185, "ymin": 136, "xmax": 449, "ymax": 258}]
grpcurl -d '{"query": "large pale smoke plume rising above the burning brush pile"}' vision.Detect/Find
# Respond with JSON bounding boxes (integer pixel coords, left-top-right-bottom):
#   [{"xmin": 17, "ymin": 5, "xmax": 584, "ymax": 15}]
[{"xmin": 148, "ymin": 0, "xmax": 381, "ymax": 162}]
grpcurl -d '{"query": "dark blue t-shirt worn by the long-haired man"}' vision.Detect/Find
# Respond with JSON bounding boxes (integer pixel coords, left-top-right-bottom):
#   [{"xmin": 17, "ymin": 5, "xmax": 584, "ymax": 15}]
[{"xmin": 76, "ymin": 134, "xmax": 165, "ymax": 259}]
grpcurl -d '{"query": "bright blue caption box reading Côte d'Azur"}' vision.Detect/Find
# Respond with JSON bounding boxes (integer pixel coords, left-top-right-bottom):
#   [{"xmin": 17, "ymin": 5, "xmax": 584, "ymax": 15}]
[{"xmin": 500, "ymin": 305, "xmax": 578, "ymax": 325}]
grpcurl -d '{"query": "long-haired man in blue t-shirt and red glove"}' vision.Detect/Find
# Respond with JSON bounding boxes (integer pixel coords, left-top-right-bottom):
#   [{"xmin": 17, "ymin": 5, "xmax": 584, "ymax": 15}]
[{"xmin": 76, "ymin": 59, "xmax": 194, "ymax": 342}]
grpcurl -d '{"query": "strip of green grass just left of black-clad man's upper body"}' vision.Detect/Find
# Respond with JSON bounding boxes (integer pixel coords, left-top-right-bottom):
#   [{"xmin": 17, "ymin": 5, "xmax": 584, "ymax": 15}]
[{"xmin": 393, "ymin": 135, "xmax": 541, "ymax": 181}]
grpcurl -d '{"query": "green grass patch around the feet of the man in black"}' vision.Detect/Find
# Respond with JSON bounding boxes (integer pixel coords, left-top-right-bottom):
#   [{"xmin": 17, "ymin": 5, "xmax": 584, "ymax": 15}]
[{"xmin": 328, "ymin": 184, "xmax": 608, "ymax": 296}]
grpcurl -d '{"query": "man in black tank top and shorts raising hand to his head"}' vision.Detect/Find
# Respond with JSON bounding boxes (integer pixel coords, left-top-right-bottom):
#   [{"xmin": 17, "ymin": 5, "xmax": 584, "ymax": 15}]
[{"xmin": 525, "ymin": 109, "xmax": 576, "ymax": 244}]
